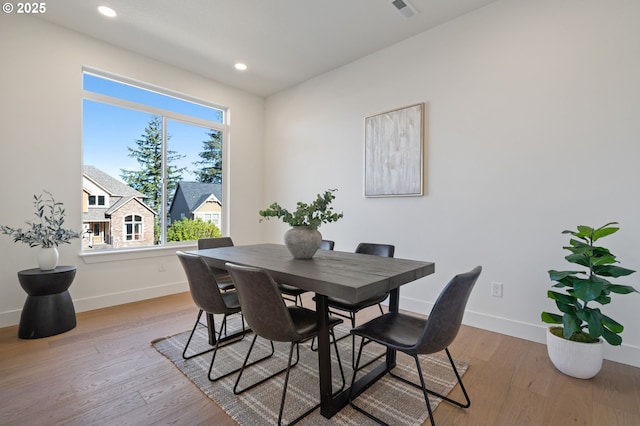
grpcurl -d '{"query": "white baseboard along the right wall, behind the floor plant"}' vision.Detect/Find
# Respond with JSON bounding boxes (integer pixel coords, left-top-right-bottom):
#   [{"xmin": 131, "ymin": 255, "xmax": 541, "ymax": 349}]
[{"xmin": 400, "ymin": 296, "xmax": 640, "ymax": 367}]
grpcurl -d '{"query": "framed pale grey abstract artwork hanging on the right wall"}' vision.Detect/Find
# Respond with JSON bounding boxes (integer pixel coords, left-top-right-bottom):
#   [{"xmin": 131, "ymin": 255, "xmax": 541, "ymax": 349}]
[{"xmin": 364, "ymin": 103, "xmax": 425, "ymax": 197}]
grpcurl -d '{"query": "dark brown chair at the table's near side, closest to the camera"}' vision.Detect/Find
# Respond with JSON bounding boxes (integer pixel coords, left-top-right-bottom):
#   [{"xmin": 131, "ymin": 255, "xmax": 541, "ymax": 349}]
[{"xmin": 227, "ymin": 263, "xmax": 344, "ymax": 425}]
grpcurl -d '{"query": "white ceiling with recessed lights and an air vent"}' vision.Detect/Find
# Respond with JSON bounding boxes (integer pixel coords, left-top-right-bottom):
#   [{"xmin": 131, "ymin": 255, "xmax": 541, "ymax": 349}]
[{"xmin": 40, "ymin": 0, "xmax": 495, "ymax": 96}]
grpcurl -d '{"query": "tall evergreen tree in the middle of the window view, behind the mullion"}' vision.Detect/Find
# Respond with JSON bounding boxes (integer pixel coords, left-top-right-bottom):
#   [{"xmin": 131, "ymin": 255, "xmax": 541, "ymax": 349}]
[{"xmin": 120, "ymin": 116, "xmax": 185, "ymax": 217}]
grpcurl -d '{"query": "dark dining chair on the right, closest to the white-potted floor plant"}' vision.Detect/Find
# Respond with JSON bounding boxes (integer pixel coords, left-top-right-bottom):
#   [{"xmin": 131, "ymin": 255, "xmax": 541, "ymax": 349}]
[{"xmin": 349, "ymin": 266, "xmax": 482, "ymax": 426}]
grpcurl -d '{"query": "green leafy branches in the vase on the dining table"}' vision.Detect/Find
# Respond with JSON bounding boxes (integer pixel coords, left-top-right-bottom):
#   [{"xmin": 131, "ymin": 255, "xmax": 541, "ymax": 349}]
[{"xmin": 258, "ymin": 189, "xmax": 343, "ymax": 229}]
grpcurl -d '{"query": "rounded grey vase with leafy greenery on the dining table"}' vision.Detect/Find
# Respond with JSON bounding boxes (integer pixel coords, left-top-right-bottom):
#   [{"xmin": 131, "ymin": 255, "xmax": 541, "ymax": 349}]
[{"xmin": 258, "ymin": 189, "xmax": 343, "ymax": 259}]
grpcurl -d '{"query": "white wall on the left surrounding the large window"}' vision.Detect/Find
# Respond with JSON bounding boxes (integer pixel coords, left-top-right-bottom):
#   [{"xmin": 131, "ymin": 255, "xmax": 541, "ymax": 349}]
[{"xmin": 0, "ymin": 14, "xmax": 264, "ymax": 327}]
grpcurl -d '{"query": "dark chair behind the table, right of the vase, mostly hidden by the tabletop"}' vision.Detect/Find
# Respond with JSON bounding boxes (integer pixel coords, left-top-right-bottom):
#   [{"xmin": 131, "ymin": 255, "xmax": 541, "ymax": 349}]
[{"xmin": 312, "ymin": 243, "xmax": 396, "ymax": 367}]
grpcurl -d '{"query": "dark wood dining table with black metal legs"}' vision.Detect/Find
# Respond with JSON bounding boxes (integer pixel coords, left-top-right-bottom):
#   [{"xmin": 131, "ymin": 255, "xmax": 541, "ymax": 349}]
[{"xmin": 190, "ymin": 244, "xmax": 435, "ymax": 418}]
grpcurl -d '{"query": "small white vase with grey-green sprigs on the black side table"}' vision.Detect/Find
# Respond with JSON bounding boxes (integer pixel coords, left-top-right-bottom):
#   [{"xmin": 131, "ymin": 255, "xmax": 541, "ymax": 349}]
[{"xmin": 0, "ymin": 191, "xmax": 80, "ymax": 271}]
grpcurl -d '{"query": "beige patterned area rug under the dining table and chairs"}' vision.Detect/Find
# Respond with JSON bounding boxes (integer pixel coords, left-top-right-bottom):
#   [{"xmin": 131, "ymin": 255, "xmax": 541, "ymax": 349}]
[{"xmin": 152, "ymin": 316, "xmax": 468, "ymax": 426}]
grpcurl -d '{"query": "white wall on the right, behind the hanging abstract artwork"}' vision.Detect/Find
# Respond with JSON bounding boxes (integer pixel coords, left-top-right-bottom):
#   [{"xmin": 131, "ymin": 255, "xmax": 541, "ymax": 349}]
[{"xmin": 262, "ymin": 0, "xmax": 640, "ymax": 366}]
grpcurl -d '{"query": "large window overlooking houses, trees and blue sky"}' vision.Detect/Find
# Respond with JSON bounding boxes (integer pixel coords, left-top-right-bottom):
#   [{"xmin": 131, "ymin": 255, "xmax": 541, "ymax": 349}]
[{"xmin": 82, "ymin": 70, "xmax": 228, "ymax": 251}]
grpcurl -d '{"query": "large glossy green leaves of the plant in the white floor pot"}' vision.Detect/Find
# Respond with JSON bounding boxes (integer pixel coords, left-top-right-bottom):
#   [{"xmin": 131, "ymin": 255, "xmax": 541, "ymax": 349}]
[{"xmin": 541, "ymin": 222, "xmax": 636, "ymax": 345}]
